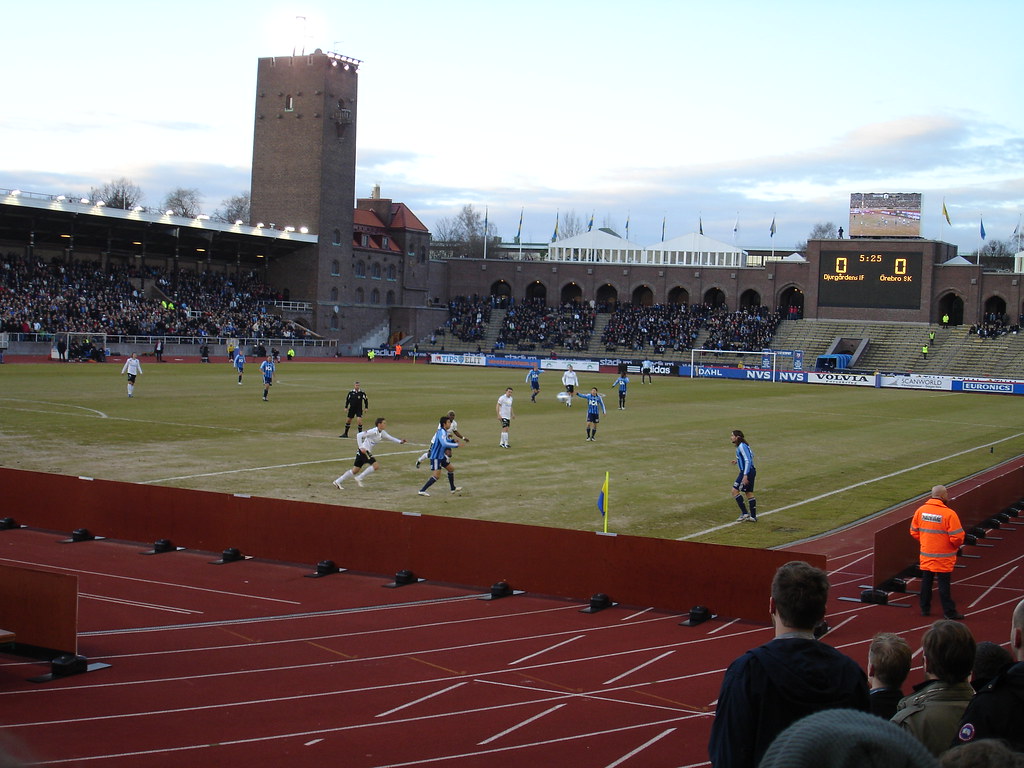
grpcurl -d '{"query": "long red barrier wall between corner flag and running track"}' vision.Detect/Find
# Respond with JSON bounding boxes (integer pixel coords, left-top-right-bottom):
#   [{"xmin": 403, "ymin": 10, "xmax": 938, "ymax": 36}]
[{"xmin": 0, "ymin": 468, "xmax": 825, "ymax": 623}]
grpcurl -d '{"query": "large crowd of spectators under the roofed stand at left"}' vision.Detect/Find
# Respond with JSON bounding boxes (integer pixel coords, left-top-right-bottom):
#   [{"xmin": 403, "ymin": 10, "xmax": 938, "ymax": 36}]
[{"xmin": 0, "ymin": 254, "xmax": 307, "ymax": 338}]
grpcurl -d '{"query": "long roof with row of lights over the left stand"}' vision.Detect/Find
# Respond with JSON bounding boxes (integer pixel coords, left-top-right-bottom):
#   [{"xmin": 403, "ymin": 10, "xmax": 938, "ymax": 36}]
[{"xmin": 0, "ymin": 190, "xmax": 316, "ymax": 262}]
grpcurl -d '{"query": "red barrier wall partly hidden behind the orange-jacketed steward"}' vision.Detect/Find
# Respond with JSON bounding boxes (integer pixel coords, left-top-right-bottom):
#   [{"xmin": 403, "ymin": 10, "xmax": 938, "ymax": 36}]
[{"xmin": 873, "ymin": 457, "xmax": 1024, "ymax": 586}]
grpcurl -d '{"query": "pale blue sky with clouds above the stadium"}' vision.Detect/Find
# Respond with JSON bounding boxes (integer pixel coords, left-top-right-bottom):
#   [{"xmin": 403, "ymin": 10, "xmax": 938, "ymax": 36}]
[{"xmin": 0, "ymin": 0, "xmax": 1024, "ymax": 252}]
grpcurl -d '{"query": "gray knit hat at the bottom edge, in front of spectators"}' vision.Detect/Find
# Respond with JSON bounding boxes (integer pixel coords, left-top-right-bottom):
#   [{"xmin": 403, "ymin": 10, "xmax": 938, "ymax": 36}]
[{"xmin": 760, "ymin": 710, "xmax": 939, "ymax": 768}]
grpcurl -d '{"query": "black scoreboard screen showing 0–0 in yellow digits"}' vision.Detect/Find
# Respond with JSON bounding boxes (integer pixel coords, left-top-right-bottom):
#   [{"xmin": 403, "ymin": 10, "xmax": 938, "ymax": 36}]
[{"xmin": 818, "ymin": 249, "xmax": 924, "ymax": 309}]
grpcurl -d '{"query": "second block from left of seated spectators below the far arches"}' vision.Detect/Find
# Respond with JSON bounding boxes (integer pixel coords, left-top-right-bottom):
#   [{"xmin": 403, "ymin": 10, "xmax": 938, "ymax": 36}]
[{"xmin": 498, "ymin": 299, "xmax": 596, "ymax": 350}]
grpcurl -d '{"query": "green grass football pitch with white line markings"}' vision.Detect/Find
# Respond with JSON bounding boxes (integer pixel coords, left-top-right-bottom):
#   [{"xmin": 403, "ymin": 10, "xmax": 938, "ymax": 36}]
[{"xmin": 0, "ymin": 360, "xmax": 1024, "ymax": 547}]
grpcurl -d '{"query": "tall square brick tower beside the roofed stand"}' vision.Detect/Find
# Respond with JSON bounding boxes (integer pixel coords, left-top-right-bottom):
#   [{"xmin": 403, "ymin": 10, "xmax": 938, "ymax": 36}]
[{"xmin": 250, "ymin": 48, "xmax": 360, "ymax": 336}]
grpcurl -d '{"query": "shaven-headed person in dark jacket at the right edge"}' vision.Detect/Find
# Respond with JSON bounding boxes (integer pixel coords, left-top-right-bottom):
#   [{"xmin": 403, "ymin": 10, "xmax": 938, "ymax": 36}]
[{"xmin": 953, "ymin": 600, "xmax": 1024, "ymax": 752}]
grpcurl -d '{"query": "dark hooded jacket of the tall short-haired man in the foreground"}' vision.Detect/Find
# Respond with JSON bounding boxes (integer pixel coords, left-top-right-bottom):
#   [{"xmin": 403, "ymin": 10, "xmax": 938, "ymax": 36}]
[{"xmin": 708, "ymin": 637, "xmax": 870, "ymax": 768}]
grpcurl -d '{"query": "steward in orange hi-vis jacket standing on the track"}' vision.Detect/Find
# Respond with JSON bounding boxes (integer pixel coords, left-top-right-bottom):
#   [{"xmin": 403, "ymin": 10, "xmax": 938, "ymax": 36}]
[{"xmin": 910, "ymin": 485, "xmax": 964, "ymax": 620}]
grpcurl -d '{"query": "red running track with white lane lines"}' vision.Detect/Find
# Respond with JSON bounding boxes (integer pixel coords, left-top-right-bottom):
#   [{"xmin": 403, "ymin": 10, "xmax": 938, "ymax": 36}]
[{"xmin": 0, "ymin": 507, "xmax": 1024, "ymax": 768}]
